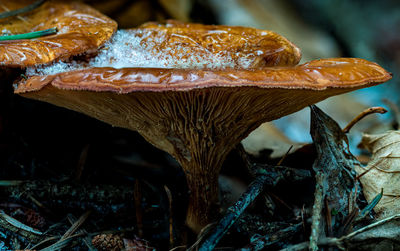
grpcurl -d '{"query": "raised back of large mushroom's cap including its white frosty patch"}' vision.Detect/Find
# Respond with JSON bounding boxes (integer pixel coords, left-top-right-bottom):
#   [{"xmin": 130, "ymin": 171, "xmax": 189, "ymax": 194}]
[{"xmin": 22, "ymin": 21, "xmax": 301, "ymax": 75}]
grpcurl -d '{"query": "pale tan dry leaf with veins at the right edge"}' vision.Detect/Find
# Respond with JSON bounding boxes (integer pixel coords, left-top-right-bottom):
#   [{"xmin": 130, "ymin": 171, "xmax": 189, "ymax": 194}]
[{"xmin": 356, "ymin": 131, "xmax": 400, "ymax": 219}]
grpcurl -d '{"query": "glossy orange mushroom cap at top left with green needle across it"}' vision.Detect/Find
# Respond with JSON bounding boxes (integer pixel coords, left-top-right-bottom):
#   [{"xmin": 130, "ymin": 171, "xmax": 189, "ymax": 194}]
[{"xmin": 0, "ymin": 1, "xmax": 117, "ymax": 68}]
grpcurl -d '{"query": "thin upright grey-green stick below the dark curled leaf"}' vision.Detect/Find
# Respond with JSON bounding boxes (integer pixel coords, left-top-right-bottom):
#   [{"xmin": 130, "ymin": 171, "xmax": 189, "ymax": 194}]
[{"xmin": 309, "ymin": 172, "xmax": 325, "ymax": 251}]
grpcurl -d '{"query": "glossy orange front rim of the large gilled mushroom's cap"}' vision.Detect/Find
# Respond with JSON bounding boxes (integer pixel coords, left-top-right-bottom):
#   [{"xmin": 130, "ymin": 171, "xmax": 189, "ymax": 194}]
[{"xmin": 15, "ymin": 58, "xmax": 391, "ymax": 94}]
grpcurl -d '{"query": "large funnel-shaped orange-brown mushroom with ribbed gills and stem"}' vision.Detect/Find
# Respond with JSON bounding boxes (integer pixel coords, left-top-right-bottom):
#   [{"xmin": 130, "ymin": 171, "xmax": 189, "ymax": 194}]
[{"xmin": 15, "ymin": 23, "xmax": 391, "ymax": 231}]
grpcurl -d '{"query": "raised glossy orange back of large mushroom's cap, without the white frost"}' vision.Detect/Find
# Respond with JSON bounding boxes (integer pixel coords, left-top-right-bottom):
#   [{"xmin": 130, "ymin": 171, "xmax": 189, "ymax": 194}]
[{"xmin": 136, "ymin": 20, "xmax": 301, "ymax": 69}]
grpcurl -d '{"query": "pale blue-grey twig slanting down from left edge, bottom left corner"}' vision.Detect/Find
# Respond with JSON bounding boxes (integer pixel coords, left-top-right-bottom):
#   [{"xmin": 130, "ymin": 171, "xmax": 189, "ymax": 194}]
[{"xmin": 0, "ymin": 210, "xmax": 43, "ymax": 242}]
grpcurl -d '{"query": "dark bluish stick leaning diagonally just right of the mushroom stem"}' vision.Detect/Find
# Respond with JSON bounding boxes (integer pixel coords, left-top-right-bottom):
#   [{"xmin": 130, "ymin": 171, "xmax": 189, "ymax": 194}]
[{"xmin": 199, "ymin": 170, "xmax": 272, "ymax": 251}]
